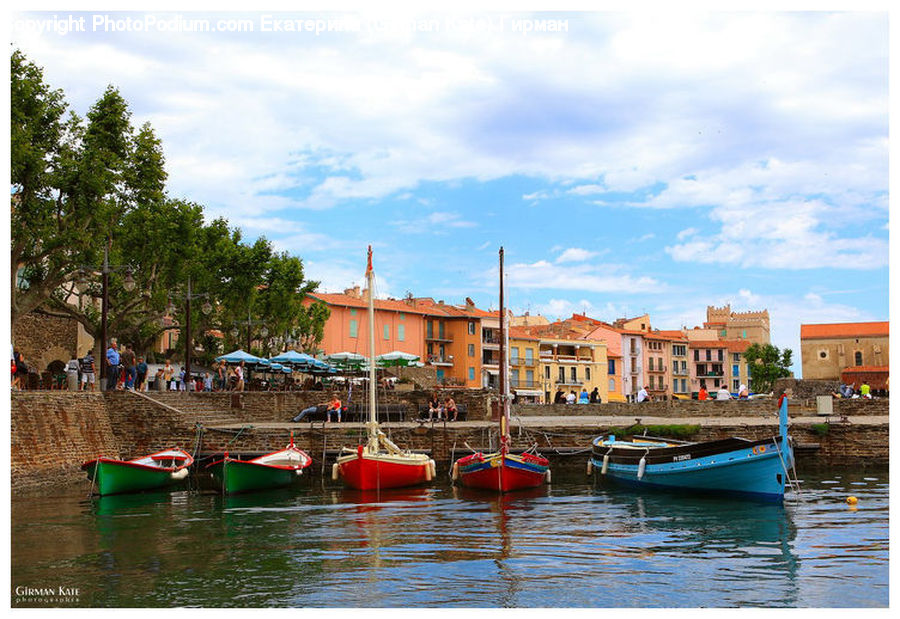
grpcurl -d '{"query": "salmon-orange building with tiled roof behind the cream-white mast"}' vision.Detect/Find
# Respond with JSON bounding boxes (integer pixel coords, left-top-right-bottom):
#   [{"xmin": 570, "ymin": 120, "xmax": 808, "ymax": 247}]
[{"xmin": 305, "ymin": 286, "xmax": 425, "ymax": 361}]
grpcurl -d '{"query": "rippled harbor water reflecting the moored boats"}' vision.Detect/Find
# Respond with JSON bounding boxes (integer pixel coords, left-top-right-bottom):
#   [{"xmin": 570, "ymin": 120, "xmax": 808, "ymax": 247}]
[{"xmin": 11, "ymin": 463, "xmax": 889, "ymax": 608}]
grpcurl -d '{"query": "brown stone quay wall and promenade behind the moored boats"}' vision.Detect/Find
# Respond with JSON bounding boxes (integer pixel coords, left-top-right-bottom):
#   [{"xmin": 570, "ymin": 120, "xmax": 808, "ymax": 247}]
[{"xmin": 11, "ymin": 392, "xmax": 889, "ymax": 490}]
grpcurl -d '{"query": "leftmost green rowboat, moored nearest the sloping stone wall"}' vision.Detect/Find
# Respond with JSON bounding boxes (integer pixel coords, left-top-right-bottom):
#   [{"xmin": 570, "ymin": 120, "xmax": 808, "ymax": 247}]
[{"xmin": 81, "ymin": 449, "xmax": 194, "ymax": 496}]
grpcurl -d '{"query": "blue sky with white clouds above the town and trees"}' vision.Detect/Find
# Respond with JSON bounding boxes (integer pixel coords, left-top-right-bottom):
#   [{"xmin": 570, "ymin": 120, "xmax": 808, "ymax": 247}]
[{"xmin": 11, "ymin": 5, "xmax": 889, "ymax": 375}]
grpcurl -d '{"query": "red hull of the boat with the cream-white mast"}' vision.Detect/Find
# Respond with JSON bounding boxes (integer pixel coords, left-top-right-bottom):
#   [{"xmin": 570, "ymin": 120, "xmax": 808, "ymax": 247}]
[{"xmin": 337, "ymin": 454, "xmax": 432, "ymax": 490}]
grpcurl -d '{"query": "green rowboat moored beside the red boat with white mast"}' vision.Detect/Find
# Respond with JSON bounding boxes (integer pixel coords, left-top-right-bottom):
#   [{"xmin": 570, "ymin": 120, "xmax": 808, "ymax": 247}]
[{"xmin": 206, "ymin": 434, "xmax": 312, "ymax": 494}]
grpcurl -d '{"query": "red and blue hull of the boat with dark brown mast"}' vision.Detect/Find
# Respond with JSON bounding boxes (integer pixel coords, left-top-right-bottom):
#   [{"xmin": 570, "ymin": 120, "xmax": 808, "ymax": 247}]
[{"xmin": 456, "ymin": 453, "xmax": 549, "ymax": 492}]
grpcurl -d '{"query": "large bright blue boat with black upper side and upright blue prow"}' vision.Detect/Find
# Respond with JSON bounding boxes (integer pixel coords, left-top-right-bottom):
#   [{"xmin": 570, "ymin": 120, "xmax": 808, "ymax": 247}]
[{"xmin": 588, "ymin": 396, "xmax": 794, "ymax": 501}]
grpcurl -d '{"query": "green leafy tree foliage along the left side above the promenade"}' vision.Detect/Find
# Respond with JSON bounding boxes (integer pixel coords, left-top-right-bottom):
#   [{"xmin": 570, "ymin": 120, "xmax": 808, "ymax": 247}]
[{"xmin": 11, "ymin": 51, "xmax": 328, "ymax": 364}]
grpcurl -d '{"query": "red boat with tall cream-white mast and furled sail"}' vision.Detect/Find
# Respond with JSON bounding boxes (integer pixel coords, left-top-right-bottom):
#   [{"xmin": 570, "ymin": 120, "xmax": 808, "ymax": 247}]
[{"xmin": 331, "ymin": 246, "xmax": 435, "ymax": 490}]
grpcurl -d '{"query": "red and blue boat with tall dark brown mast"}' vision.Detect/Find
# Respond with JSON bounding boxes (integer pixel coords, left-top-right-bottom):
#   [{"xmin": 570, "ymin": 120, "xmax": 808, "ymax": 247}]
[{"xmin": 452, "ymin": 247, "xmax": 550, "ymax": 492}]
